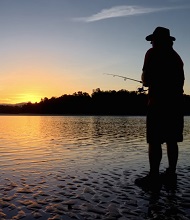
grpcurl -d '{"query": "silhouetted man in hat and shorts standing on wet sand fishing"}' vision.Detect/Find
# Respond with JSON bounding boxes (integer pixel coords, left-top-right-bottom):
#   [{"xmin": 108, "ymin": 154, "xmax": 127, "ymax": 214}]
[{"xmin": 135, "ymin": 27, "xmax": 185, "ymax": 187}]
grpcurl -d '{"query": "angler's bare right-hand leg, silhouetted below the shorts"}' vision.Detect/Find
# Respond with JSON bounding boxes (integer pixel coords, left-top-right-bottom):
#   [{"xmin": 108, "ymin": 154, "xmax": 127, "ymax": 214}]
[{"xmin": 167, "ymin": 142, "xmax": 178, "ymax": 173}]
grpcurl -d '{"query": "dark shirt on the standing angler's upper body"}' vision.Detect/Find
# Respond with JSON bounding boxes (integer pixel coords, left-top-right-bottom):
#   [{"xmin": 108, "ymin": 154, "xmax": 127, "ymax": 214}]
[{"xmin": 143, "ymin": 48, "xmax": 184, "ymax": 103}]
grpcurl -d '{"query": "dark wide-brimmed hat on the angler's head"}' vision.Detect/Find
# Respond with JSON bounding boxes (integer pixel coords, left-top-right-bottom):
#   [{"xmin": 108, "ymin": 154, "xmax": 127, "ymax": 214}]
[{"xmin": 145, "ymin": 27, "xmax": 175, "ymax": 41}]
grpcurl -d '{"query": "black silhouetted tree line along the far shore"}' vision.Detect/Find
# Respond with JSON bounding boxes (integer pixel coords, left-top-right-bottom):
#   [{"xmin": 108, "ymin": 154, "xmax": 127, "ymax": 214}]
[{"xmin": 0, "ymin": 88, "xmax": 190, "ymax": 115}]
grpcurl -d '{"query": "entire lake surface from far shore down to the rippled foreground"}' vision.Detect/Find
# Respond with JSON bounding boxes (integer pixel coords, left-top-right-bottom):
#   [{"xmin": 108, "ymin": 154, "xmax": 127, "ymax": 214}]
[{"xmin": 0, "ymin": 116, "xmax": 190, "ymax": 220}]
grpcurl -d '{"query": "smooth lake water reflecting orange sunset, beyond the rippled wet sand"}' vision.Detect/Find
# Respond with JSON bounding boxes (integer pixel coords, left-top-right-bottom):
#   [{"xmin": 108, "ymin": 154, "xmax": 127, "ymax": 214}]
[{"xmin": 0, "ymin": 116, "xmax": 190, "ymax": 174}]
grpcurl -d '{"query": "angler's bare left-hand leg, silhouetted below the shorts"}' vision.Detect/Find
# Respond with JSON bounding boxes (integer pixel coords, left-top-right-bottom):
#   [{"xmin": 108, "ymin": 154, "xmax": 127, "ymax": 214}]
[{"xmin": 148, "ymin": 143, "xmax": 162, "ymax": 175}]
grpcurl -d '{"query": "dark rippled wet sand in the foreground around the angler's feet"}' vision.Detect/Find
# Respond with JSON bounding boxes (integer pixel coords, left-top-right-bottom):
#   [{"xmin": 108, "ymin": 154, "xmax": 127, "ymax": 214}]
[{"xmin": 0, "ymin": 151, "xmax": 190, "ymax": 220}]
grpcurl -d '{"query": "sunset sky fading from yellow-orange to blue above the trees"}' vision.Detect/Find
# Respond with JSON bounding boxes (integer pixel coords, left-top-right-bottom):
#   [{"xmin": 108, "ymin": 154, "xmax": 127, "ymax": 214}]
[{"xmin": 0, "ymin": 0, "xmax": 190, "ymax": 103}]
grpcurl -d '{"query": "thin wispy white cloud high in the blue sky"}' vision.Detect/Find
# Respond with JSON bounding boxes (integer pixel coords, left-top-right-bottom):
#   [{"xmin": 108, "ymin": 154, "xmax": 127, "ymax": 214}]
[{"xmin": 74, "ymin": 5, "xmax": 186, "ymax": 22}]
